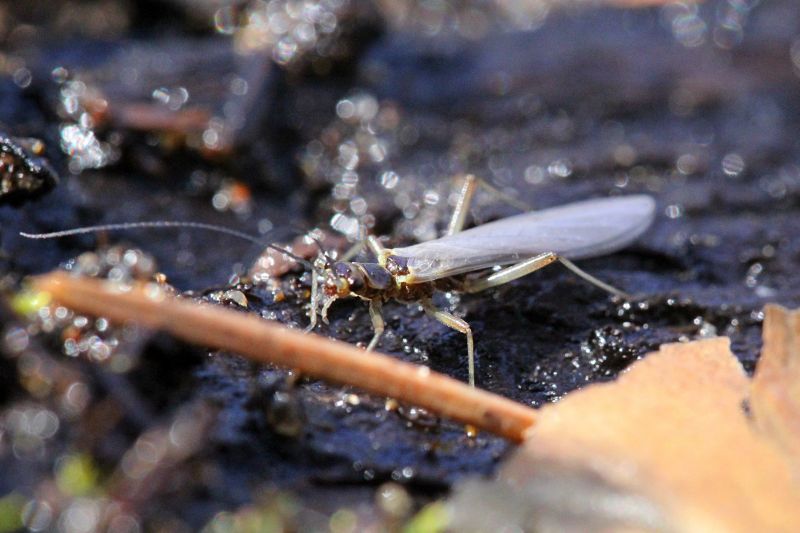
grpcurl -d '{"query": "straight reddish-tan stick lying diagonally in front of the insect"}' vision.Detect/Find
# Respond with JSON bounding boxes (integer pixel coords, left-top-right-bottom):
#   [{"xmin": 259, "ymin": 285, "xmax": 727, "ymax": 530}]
[{"xmin": 33, "ymin": 272, "xmax": 536, "ymax": 442}]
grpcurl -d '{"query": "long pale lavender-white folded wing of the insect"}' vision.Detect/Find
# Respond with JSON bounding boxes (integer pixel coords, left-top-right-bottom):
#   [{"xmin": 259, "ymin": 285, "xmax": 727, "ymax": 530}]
[{"xmin": 389, "ymin": 195, "xmax": 655, "ymax": 283}]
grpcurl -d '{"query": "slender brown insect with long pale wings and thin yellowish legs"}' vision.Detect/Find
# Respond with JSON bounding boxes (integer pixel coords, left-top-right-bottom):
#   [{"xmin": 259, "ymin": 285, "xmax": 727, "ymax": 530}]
[{"xmin": 308, "ymin": 183, "xmax": 655, "ymax": 386}]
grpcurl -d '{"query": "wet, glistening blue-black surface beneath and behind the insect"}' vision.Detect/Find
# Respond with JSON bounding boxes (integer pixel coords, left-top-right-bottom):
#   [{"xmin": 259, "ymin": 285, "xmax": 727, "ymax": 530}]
[{"xmin": 0, "ymin": 2, "xmax": 800, "ymax": 528}]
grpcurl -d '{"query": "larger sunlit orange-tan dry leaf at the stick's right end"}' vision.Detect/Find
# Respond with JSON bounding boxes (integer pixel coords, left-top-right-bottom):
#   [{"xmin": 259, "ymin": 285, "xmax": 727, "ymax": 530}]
[{"xmin": 501, "ymin": 338, "xmax": 800, "ymax": 531}]
